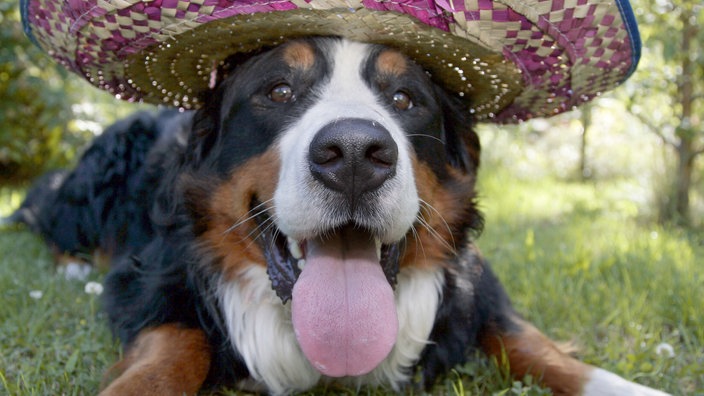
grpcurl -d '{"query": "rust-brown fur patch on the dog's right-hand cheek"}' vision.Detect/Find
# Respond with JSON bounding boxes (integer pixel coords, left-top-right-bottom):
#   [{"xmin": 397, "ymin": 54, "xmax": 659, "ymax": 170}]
[{"xmin": 401, "ymin": 158, "xmax": 475, "ymax": 267}]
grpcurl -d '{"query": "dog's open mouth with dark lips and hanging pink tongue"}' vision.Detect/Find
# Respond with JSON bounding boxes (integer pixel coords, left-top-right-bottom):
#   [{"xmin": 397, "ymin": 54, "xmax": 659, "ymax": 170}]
[{"xmin": 257, "ymin": 206, "xmax": 400, "ymax": 377}]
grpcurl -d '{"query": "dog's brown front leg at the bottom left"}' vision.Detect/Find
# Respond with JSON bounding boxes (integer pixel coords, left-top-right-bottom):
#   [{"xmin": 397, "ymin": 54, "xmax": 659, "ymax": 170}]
[{"xmin": 100, "ymin": 324, "xmax": 211, "ymax": 396}]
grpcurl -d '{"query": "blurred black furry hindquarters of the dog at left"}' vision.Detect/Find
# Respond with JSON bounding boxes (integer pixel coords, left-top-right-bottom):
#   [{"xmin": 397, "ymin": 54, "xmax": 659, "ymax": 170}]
[{"xmin": 4, "ymin": 109, "xmax": 185, "ymax": 266}]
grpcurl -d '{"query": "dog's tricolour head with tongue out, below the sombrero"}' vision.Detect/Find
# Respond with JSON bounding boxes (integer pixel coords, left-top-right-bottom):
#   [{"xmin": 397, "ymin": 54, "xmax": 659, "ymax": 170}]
[{"xmin": 184, "ymin": 38, "xmax": 481, "ymax": 376}]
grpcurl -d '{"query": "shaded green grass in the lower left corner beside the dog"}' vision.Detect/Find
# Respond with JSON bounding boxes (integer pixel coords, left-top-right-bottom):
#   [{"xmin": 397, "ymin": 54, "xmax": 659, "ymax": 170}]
[{"xmin": 0, "ymin": 223, "xmax": 117, "ymax": 395}]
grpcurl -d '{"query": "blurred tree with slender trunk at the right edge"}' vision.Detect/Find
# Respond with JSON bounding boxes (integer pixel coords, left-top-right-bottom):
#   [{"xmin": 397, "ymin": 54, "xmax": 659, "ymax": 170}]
[{"xmin": 626, "ymin": 0, "xmax": 704, "ymax": 223}]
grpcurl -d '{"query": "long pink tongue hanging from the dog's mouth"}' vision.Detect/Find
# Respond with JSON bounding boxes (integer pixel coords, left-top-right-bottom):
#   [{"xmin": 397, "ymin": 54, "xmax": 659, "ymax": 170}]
[{"xmin": 291, "ymin": 229, "xmax": 398, "ymax": 377}]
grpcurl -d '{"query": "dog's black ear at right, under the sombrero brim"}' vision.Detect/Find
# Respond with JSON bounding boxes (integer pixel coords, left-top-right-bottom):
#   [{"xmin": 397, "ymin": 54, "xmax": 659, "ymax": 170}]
[{"xmin": 435, "ymin": 86, "xmax": 481, "ymax": 173}]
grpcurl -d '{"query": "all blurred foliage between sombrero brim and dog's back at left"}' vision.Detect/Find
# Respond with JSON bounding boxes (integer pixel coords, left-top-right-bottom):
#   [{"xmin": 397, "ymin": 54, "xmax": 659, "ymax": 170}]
[{"xmin": 0, "ymin": 0, "xmax": 146, "ymax": 184}]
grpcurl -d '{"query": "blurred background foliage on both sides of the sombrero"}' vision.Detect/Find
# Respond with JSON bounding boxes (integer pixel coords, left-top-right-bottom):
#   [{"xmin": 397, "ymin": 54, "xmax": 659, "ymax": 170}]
[{"xmin": 0, "ymin": 0, "xmax": 704, "ymax": 226}]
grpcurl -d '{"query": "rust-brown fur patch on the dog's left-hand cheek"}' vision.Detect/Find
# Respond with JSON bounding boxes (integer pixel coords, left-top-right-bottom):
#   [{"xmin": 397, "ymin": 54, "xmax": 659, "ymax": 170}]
[{"xmin": 192, "ymin": 149, "xmax": 279, "ymax": 278}]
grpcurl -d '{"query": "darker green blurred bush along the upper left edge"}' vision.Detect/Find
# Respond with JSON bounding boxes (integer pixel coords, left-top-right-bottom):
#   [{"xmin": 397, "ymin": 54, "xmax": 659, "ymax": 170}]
[{"xmin": 0, "ymin": 0, "xmax": 77, "ymax": 181}]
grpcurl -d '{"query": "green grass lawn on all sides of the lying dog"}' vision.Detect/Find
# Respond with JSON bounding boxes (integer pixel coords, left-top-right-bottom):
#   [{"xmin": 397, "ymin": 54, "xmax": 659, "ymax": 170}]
[{"xmin": 0, "ymin": 168, "xmax": 704, "ymax": 395}]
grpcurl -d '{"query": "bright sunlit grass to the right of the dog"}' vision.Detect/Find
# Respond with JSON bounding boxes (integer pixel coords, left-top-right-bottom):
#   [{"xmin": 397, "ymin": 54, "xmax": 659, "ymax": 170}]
[{"xmin": 479, "ymin": 172, "xmax": 704, "ymax": 394}]
